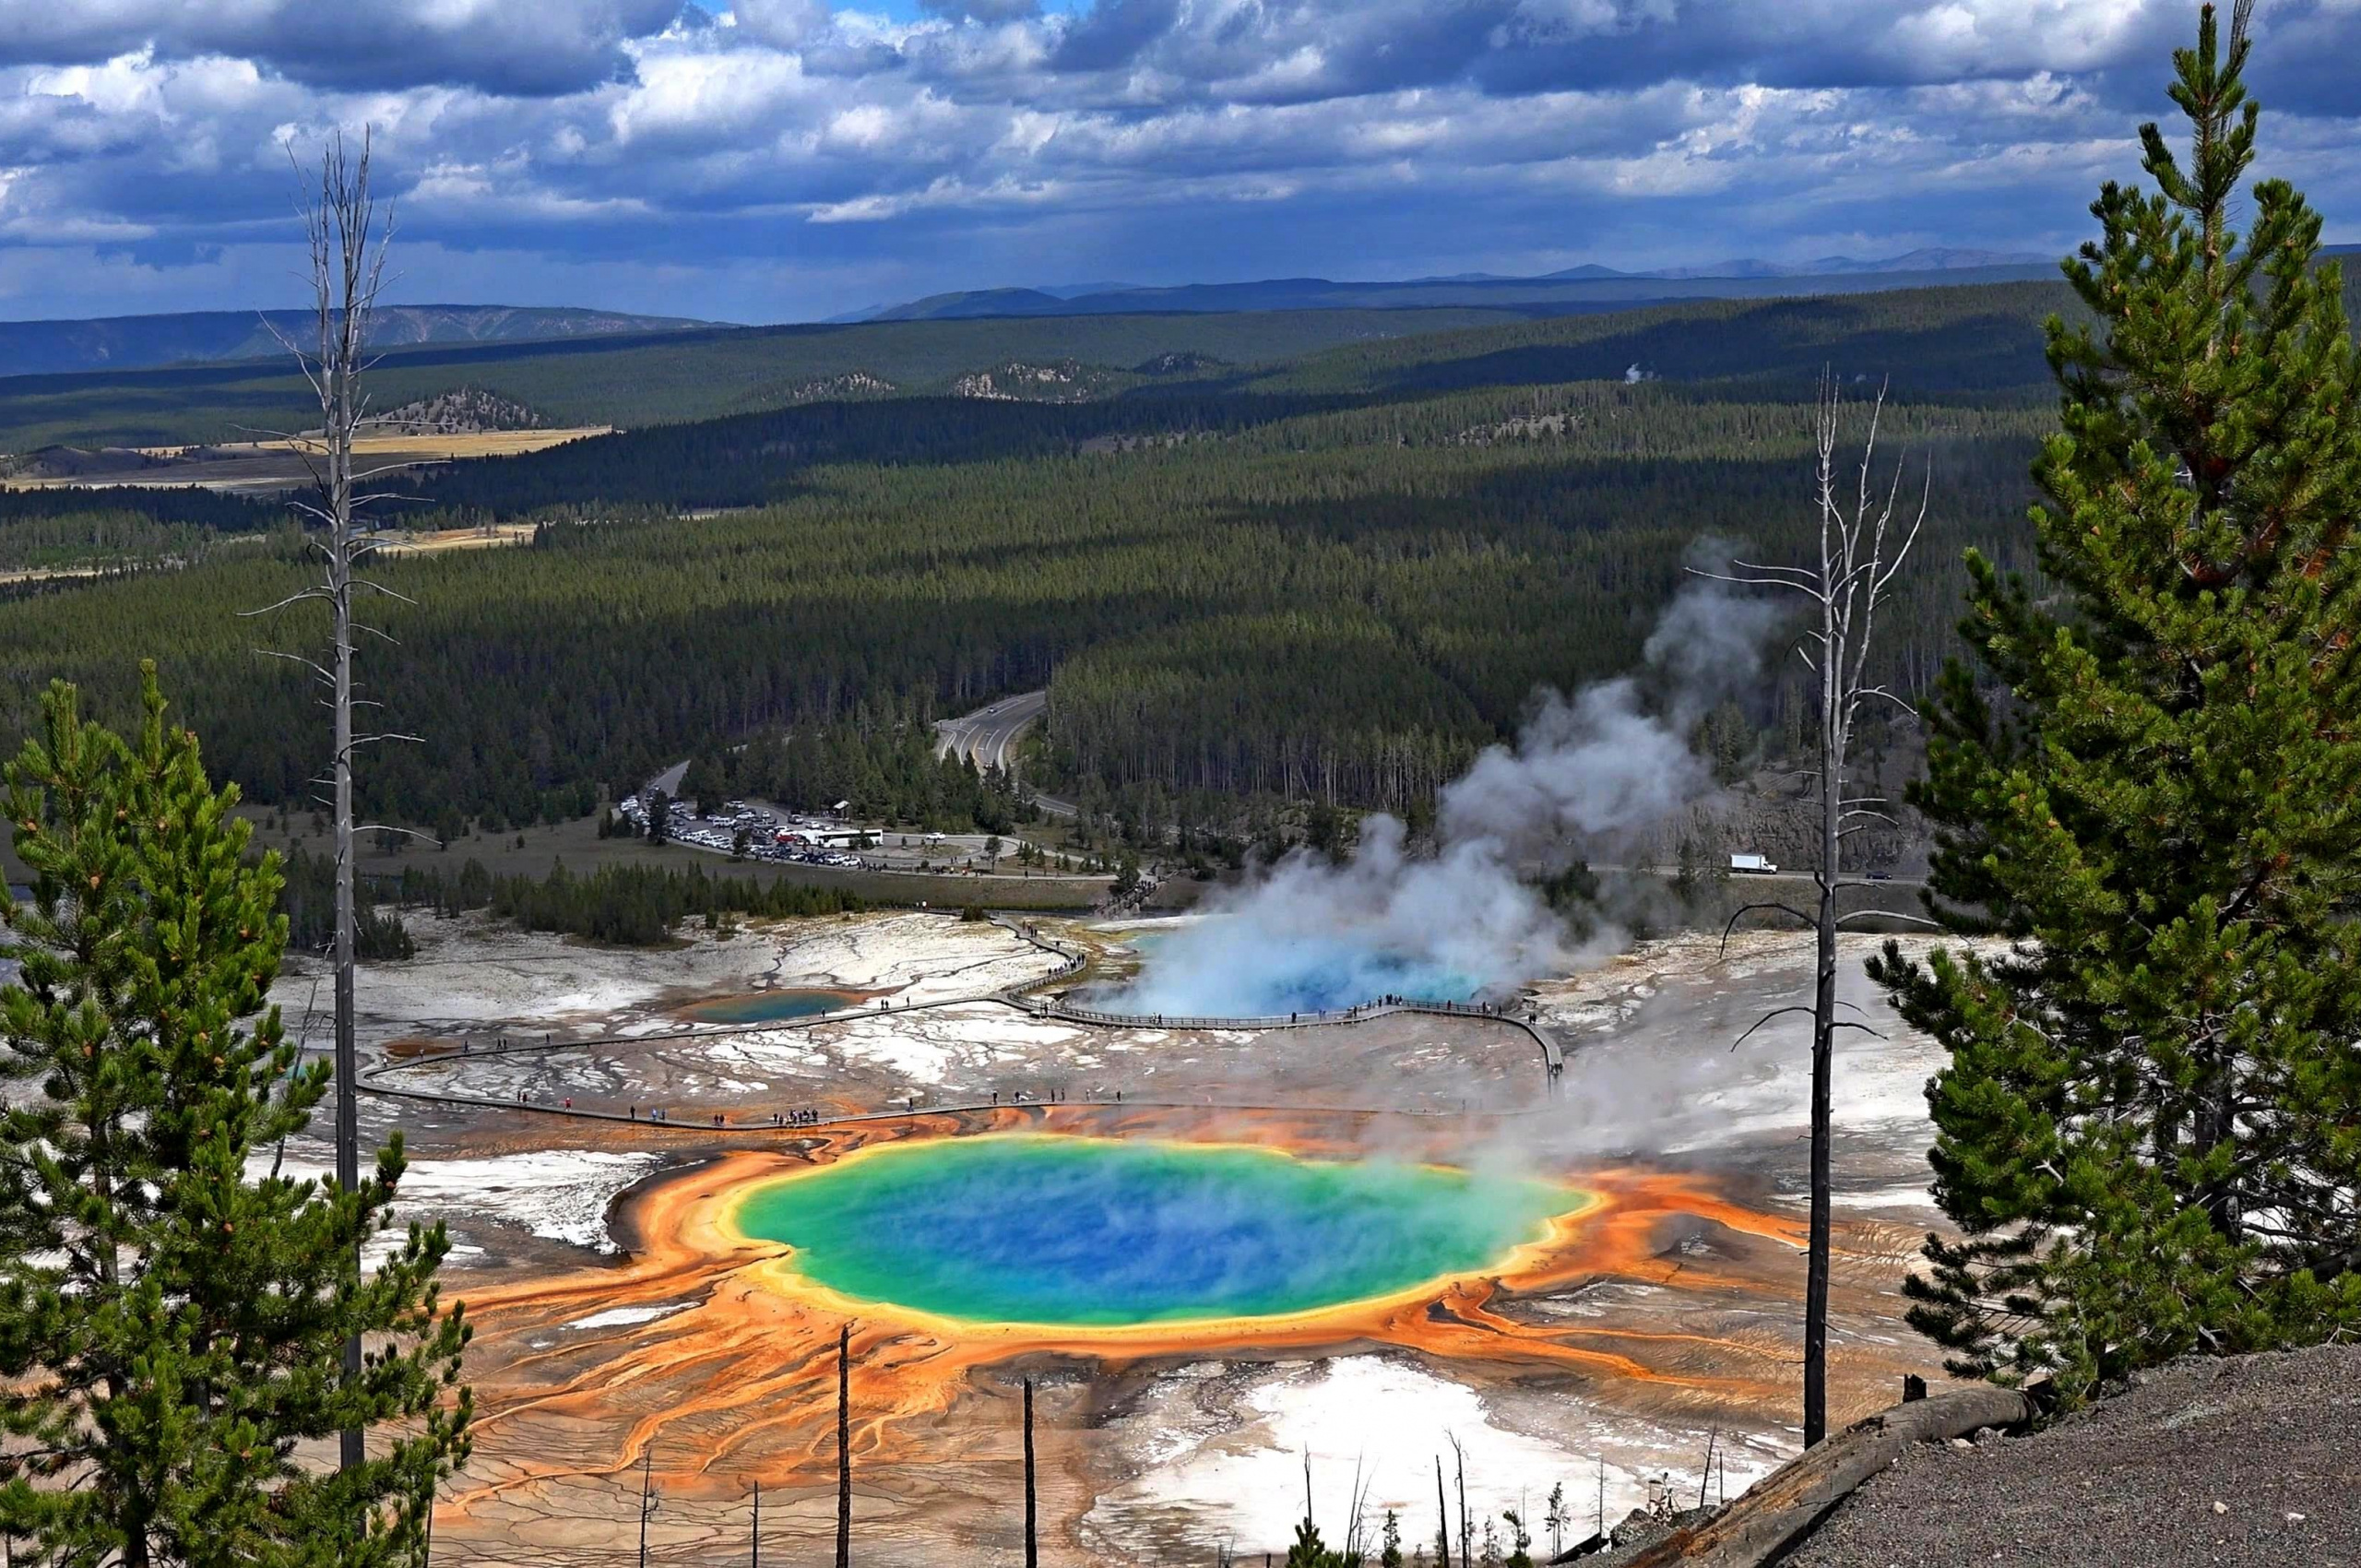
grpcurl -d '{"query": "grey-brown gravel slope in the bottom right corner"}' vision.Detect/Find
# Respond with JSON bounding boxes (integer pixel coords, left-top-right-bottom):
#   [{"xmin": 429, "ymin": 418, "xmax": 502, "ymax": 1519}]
[{"xmin": 1783, "ymin": 1346, "xmax": 2361, "ymax": 1568}]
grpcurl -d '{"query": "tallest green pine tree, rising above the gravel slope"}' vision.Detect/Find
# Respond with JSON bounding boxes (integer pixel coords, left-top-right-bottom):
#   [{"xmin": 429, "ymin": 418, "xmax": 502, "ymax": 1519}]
[{"xmin": 1872, "ymin": 0, "xmax": 2361, "ymax": 1398}]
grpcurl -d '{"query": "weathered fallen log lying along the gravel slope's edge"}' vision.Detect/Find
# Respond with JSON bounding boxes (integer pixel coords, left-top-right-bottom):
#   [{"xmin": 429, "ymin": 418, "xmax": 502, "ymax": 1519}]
[{"xmin": 1624, "ymin": 1384, "xmax": 2033, "ymax": 1568}]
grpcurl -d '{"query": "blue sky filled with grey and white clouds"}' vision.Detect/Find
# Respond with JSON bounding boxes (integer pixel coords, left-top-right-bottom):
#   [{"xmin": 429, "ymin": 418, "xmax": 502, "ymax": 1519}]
[{"xmin": 0, "ymin": 0, "xmax": 2361, "ymax": 321}]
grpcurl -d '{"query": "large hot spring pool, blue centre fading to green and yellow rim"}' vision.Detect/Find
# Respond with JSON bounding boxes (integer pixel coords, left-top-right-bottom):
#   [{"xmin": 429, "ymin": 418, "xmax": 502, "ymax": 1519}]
[{"xmin": 734, "ymin": 1134, "xmax": 1584, "ymax": 1327}]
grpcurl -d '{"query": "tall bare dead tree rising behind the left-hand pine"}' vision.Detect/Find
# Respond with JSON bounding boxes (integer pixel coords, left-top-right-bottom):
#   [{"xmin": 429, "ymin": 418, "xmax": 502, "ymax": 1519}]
[{"xmin": 248, "ymin": 130, "xmax": 416, "ymax": 1468}]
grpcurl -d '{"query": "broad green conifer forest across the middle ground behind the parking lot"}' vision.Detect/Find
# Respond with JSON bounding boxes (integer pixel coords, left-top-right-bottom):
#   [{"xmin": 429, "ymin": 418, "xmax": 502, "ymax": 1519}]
[{"xmin": 0, "ymin": 383, "xmax": 2037, "ymax": 822}]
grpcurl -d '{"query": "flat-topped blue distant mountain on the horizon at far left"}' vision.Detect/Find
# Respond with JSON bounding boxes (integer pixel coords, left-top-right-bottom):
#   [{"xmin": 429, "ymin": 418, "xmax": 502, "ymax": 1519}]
[{"xmin": 0, "ymin": 304, "xmax": 720, "ymax": 375}]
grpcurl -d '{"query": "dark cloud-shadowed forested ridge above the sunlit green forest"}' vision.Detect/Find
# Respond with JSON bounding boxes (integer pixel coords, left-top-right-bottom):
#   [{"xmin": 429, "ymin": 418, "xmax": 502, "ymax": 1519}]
[{"xmin": 382, "ymin": 283, "xmax": 2069, "ymax": 517}]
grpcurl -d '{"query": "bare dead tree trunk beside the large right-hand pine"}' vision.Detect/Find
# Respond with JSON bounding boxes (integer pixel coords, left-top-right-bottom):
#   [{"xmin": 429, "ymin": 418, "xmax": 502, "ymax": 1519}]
[{"xmin": 1703, "ymin": 378, "xmax": 1931, "ymax": 1447}]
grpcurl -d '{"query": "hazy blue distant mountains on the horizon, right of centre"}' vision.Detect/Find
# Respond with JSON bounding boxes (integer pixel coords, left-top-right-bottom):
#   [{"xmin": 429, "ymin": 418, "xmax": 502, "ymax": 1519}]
[{"xmin": 859, "ymin": 248, "xmax": 2057, "ymax": 321}]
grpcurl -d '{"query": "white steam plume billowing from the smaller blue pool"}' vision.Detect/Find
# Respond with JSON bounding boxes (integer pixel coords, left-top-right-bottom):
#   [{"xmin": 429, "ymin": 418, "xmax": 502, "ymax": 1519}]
[{"xmin": 1114, "ymin": 581, "xmax": 1774, "ymax": 1017}]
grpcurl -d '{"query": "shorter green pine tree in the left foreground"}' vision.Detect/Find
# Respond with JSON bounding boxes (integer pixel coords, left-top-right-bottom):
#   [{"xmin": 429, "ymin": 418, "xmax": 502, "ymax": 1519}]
[{"xmin": 0, "ymin": 671, "xmax": 468, "ymax": 1568}]
